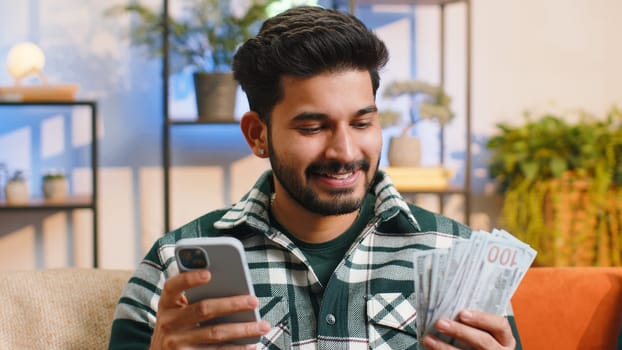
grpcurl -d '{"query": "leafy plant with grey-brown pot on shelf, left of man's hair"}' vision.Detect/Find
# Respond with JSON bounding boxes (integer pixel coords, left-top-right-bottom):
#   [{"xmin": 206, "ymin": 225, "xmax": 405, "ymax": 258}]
[{"xmin": 106, "ymin": 0, "xmax": 276, "ymax": 121}]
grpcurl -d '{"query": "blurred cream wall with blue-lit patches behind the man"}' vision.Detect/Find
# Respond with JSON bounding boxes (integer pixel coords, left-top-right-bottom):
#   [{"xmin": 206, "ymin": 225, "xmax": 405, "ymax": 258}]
[{"xmin": 0, "ymin": 0, "xmax": 622, "ymax": 269}]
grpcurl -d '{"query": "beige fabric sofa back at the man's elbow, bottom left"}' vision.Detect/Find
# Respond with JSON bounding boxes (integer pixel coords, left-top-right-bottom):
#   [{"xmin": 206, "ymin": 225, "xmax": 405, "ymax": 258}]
[{"xmin": 0, "ymin": 268, "xmax": 131, "ymax": 350}]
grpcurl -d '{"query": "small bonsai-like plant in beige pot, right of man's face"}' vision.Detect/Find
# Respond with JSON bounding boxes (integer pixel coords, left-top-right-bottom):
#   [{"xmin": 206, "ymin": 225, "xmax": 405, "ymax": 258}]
[{"xmin": 379, "ymin": 80, "xmax": 454, "ymax": 167}]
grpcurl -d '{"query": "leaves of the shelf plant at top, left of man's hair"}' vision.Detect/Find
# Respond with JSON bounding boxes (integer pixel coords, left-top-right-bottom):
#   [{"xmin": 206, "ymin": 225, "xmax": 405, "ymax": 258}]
[{"xmin": 104, "ymin": 0, "xmax": 275, "ymax": 72}]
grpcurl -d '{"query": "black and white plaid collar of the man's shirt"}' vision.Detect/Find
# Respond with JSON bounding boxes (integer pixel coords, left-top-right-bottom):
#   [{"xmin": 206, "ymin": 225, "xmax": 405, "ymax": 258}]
[{"xmin": 214, "ymin": 170, "xmax": 421, "ymax": 232}]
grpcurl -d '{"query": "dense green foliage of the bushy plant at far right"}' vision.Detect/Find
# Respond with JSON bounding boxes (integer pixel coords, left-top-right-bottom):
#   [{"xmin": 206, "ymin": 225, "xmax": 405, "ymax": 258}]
[{"xmin": 486, "ymin": 107, "xmax": 622, "ymax": 192}]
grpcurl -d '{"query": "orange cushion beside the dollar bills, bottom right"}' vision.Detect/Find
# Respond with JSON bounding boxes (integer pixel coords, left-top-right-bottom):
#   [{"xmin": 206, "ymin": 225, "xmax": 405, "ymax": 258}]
[{"xmin": 512, "ymin": 267, "xmax": 622, "ymax": 350}]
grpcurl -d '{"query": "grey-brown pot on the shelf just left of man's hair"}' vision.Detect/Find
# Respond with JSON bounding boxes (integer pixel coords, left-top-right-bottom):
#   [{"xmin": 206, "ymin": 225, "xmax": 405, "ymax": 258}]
[{"xmin": 194, "ymin": 72, "xmax": 237, "ymax": 122}]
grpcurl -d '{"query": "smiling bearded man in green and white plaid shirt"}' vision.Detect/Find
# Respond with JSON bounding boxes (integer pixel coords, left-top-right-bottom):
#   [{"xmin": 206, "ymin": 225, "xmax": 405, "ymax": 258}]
[{"xmin": 110, "ymin": 7, "xmax": 516, "ymax": 349}]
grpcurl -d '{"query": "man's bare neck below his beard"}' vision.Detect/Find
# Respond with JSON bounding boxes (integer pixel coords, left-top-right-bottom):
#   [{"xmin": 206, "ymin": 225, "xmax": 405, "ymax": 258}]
[{"xmin": 272, "ymin": 190, "xmax": 359, "ymax": 243}]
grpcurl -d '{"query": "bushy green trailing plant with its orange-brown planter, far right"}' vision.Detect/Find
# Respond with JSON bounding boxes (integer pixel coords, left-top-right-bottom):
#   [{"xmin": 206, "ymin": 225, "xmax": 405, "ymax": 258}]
[{"xmin": 486, "ymin": 107, "xmax": 622, "ymax": 266}]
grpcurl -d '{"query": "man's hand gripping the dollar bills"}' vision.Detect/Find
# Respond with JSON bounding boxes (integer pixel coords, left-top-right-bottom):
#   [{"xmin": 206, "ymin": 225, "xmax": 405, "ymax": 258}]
[{"xmin": 423, "ymin": 310, "xmax": 516, "ymax": 350}]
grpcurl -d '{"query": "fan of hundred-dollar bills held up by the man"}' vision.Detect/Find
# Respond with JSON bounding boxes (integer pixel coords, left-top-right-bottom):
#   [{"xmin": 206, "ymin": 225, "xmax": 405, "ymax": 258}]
[{"xmin": 414, "ymin": 229, "xmax": 536, "ymax": 349}]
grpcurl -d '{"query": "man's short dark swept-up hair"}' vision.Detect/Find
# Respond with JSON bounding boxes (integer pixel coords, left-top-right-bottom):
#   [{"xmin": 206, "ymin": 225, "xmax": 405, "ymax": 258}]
[{"xmin": 233, "ymin": 6, "xmax": 389, "ymax": 123}]
